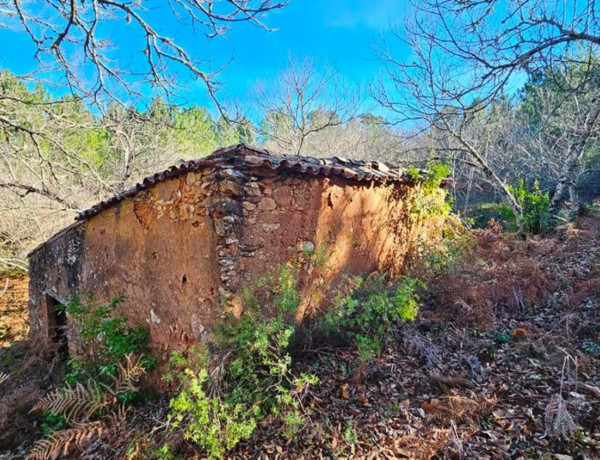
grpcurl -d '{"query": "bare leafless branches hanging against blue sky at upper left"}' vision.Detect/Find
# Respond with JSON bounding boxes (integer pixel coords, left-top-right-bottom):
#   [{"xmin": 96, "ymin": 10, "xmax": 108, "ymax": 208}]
[{"xmin": 0, "ymin": 0, "xmax": 288, "ymax": 107}]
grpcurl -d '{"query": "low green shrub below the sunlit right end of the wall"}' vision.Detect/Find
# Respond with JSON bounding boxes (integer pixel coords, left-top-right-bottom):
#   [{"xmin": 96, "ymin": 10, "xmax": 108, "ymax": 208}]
[{"xmin": 319, "ymin": 276, "xmax": 425, "ymax": 362}]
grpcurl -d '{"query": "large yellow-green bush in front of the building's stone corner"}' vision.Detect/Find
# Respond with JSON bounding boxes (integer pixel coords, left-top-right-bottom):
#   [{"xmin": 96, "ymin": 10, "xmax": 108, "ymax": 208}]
[{"xmin": 169, "ymin": 266, "xmax": 317, "ymax": 458}]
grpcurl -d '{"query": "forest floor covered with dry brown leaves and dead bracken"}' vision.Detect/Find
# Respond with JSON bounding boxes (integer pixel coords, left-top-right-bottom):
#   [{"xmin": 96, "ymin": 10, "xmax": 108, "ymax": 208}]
[{"xmin": 0, "ymin": 211, "xmax": 600, "ymax": 460}]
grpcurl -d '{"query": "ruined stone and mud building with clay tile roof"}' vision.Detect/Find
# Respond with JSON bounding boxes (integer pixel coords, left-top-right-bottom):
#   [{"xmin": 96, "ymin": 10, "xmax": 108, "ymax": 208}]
[{"xmin": 29, "ymin": 145, "xmax": 440, "ymax": 356}]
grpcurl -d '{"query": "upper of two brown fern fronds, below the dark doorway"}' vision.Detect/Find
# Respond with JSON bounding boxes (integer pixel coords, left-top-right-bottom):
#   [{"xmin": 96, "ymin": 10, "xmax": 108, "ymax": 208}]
[{"xmin": 31, "ymin": 380, "xmax": 114, "ymax": 425}]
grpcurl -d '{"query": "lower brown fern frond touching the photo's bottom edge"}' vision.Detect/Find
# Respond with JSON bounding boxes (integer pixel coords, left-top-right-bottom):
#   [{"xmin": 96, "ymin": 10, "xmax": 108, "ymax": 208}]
[{"xmin": 26, "ymin": 421, "xmax": 105, "ymax": 460}]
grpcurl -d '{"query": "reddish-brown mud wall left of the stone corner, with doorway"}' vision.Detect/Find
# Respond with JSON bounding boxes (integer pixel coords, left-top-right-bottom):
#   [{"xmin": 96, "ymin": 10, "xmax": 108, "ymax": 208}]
[{"xmin": 30, "ymin": 171, "xmax": 222, "ymax": 358}]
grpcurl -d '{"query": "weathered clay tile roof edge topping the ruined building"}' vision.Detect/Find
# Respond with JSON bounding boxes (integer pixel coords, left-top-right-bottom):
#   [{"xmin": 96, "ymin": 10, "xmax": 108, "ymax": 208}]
[{"xmin": 76, "ymin": 144, "xmax": 420, "ymax": 220}]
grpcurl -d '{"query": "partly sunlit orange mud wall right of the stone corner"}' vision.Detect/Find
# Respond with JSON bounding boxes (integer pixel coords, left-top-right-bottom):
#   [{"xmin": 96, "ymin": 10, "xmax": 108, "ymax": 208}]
[{"xmin": 213, "ymin": 170, "xmax": 420, "ymax": 319}]
